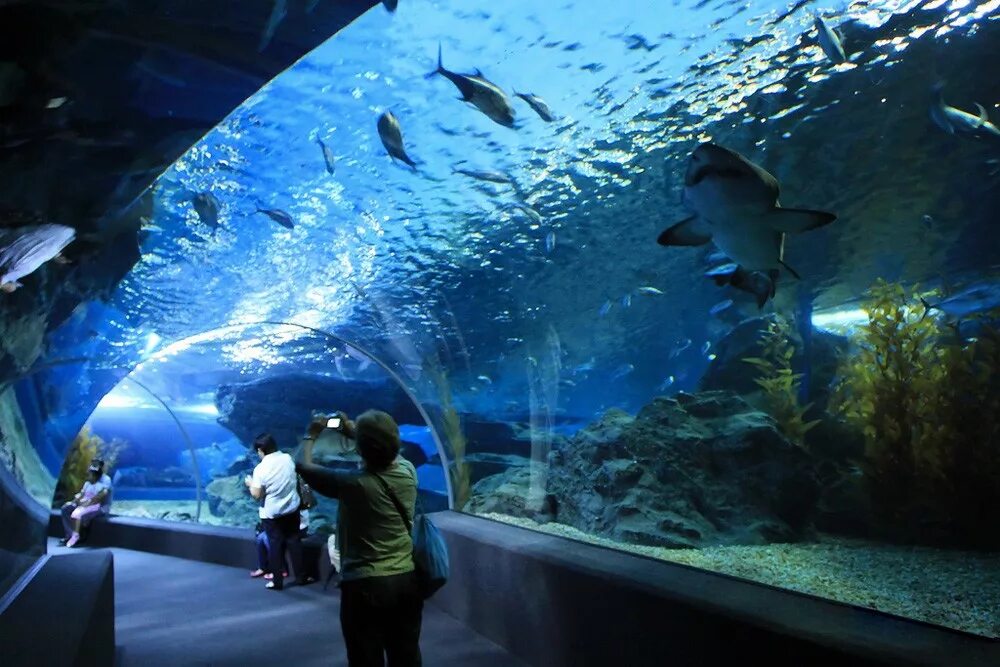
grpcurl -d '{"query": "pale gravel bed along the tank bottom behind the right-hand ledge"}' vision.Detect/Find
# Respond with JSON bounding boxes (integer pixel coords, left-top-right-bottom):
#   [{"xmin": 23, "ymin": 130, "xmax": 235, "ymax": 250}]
[{"xmin": 480, "ymin": 513, "xmax": 1000, "ymax": 638}]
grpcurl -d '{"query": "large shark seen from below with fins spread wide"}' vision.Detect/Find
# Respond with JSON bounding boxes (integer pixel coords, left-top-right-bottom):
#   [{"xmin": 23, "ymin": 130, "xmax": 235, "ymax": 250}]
[{"xmin": 657, "ymin": 142, "xmax": 837, "ymax": 307}]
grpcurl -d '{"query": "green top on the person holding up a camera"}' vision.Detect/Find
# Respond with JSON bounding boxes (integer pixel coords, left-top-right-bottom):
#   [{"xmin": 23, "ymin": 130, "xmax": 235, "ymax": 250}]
[{"xmin": 296, "ymin": 457, "xmax": 417, "ymax": 581}]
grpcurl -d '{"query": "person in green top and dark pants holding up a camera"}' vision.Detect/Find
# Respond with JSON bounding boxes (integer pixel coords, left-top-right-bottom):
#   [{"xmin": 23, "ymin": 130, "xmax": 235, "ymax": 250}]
[{"xmin": 296, "ymin": 410, "xmax": 424, "ymax": 667}]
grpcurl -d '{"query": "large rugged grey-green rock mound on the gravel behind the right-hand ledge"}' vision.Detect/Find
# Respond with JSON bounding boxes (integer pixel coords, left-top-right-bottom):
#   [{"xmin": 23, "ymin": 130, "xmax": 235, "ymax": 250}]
[{"xmin": 469, "ymin": 391, "xmax": 819, "ymax": 548}]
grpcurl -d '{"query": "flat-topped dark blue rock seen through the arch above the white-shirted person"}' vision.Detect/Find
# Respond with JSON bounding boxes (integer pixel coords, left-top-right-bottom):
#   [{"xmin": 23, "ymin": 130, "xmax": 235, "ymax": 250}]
[{"xmin": 215, "ymin": 373, "xmax": 424, "ymax": 449}]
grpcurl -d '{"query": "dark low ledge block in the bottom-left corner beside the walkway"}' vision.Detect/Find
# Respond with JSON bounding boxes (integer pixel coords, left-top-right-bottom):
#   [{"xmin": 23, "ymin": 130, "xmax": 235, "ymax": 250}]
[{"xmin": 0, "ymin": 551, "xmax": 115, "ymax": 667}]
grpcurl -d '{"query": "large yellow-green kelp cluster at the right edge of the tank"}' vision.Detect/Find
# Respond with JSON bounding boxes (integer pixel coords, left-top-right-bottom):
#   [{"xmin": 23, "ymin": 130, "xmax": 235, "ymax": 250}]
[{"xmin": 835, "ymin": 280, "xmax": 1000, "ymax": 547}]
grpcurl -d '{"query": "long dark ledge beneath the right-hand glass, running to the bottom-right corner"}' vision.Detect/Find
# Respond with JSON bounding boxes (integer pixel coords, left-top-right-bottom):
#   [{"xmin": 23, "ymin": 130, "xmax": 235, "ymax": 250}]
[{"xmin": 431, "ymin": 512, "xmax": 1000, "ymax": 667}]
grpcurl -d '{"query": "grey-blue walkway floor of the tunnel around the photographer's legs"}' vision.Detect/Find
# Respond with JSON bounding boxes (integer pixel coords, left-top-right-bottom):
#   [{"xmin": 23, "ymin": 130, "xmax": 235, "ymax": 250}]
[{"xmin": 49, "ymin": 540, "xmax": 524, "ymax": 667}]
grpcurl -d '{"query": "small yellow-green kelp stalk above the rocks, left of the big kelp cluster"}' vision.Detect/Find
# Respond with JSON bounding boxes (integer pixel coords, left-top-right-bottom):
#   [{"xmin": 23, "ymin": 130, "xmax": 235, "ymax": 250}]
[{"xmin": 743, "ymin": 315, "xmax": 820, "ymax": 448}]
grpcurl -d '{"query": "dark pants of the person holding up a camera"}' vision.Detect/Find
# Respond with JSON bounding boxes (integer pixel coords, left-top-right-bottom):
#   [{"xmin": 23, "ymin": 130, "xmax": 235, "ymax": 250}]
[{"xmin": 340, "ymin": 572, "xmax": 424, "ymax": 667}]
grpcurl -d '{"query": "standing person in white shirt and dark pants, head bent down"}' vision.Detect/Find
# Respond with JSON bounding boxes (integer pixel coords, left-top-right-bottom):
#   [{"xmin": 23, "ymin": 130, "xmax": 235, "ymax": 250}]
[{"xmin": 244, "ymin": 433, "xmax": 310, "ymax": 591}]
